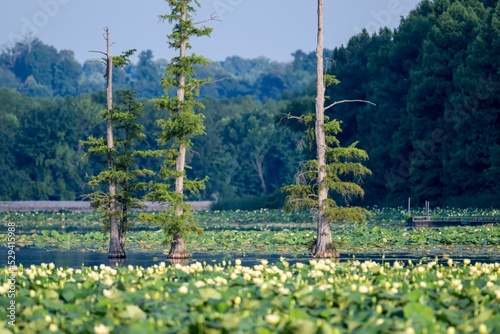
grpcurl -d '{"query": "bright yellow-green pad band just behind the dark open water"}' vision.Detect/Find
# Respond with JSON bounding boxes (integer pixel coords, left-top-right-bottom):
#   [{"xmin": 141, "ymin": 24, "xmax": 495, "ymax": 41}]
[{"xmin": 0, "ymin": 225, "xmax": 500, "ymax": 255}]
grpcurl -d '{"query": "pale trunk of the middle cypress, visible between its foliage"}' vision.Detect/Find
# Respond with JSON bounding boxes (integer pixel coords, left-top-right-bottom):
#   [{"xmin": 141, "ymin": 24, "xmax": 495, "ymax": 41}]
[{"xmin": 168, "ymin": 5, "xmax": 189, "ymax": 259}]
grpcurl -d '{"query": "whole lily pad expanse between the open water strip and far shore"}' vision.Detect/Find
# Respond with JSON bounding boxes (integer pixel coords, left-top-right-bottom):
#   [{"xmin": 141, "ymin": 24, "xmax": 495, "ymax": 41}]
[{"xmin": 0, "ymin": 208, "xmax": 500, "ymax": 257}]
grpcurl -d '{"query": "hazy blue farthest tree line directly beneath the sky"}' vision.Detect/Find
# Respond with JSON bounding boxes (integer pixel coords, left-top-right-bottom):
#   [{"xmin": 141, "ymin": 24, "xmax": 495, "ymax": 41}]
[{"xmin": 0, "ymin": 37, "xmax": 320, "ymax": 101}]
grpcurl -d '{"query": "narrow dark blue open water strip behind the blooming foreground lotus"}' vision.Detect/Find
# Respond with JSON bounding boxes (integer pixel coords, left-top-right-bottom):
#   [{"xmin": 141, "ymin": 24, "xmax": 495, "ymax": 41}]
[{"xmin": 0, "ymin": 246, "xmax": 500, "ymax": 268}]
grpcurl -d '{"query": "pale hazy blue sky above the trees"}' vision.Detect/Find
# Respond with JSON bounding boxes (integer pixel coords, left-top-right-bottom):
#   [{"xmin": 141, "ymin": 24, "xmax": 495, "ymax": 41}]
[{"xmin": 0, "ymin": 0, "xmax": 420, "ymax": 61}]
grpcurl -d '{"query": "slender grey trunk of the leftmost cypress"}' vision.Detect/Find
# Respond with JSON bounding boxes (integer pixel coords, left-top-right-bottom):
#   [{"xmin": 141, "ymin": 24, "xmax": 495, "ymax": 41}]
[{"xmin": 105, "ymin": 28, "xmax": 125, "ymax": 258}]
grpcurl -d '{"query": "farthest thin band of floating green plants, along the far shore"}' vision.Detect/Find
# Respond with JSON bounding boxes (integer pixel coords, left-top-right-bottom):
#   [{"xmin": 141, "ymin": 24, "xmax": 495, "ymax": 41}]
[{"xmin": 0, "ymin": 207, "xmax": 500, "ymax": 231}]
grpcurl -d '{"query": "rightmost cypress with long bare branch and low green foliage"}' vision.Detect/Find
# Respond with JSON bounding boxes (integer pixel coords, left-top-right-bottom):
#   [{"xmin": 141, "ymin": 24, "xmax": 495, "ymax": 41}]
[{"xmin": 283, "ymin": 0, "xmax": 371, "ymax": 258}]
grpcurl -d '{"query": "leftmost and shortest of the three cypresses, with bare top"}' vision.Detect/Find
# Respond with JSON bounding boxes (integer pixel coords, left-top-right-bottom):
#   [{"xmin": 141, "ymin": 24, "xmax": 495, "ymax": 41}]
[{"xmin": 81, "ymin": 28, "xmax": 144, "ymax": 258}]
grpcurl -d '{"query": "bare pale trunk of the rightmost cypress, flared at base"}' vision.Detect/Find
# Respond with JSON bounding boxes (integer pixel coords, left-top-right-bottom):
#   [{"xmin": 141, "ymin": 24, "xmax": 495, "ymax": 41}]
[{"xmin": 313, "ymin": 0, "xmax": 339, "ymax": 258}]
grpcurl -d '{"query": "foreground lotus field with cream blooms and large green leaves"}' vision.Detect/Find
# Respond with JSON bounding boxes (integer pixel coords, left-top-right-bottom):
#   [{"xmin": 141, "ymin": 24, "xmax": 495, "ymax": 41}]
[{"xmin": 0, "ymin": 260, "xmax": 500, "ymax": 334}]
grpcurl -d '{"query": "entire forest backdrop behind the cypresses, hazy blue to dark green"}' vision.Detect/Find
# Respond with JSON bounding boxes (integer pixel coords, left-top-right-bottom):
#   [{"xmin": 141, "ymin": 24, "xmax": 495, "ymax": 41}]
[{"xmin": 0, "ymin": 0, "xmax": 500, "ymax": 206}]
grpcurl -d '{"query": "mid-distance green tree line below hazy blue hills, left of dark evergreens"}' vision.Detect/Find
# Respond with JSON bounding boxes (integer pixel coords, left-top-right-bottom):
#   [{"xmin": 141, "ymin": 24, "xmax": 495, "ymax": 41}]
[{"xmin": 0, "ymin": 89, "xmax": 302, "ymax": 205}]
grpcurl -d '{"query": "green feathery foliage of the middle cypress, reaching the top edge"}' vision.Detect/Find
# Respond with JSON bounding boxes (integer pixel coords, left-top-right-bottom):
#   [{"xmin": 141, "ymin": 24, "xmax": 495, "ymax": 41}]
[{"xmin": 140, "ymin": 0, "xmax": 212, "ymax": 243}]
